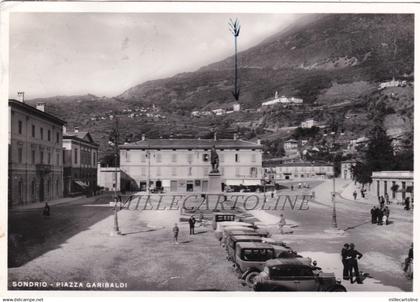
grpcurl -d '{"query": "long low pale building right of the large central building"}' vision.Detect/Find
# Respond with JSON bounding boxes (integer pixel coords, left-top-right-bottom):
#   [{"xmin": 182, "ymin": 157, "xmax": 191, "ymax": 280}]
[{"xmin": 264, "ymin": 161, "xmax": 334, "ymax": 181}]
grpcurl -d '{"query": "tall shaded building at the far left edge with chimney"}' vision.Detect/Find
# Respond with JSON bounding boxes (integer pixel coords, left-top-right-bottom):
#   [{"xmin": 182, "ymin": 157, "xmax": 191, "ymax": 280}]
[{"xmin": 8, "ymin": 100, "xmax": 65, "ymax": 206}]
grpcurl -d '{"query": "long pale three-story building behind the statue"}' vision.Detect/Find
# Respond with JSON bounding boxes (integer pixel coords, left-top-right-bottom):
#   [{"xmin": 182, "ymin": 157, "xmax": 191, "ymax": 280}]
[{"xmin": 120, "ymin": 139, "xmax": 262, "ymax": 192}]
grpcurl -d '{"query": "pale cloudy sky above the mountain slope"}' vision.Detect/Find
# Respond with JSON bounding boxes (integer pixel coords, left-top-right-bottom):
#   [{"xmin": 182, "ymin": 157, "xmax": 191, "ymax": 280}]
[{"xmin": 9, "ymin": 13, "xmax": 298, "ymax": 99}]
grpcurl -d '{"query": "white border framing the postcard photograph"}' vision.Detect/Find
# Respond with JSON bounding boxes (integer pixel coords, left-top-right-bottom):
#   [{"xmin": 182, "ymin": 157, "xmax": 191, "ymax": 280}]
[{"xmin": 0, "ymin": 1, "xmax": 420, "ymax": 302}]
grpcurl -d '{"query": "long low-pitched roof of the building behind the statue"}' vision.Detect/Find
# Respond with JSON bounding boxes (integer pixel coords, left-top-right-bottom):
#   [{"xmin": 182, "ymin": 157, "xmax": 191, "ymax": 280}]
[{"xmin": 119, "ymin": 139, "xmax": 262, "ymax": 149}]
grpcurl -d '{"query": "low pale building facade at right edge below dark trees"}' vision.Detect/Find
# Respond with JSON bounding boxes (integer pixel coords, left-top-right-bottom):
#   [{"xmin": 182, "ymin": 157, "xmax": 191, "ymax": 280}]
[{"xmin": 371, "ymin": 171, "xmax": 414, "ymax": 201}]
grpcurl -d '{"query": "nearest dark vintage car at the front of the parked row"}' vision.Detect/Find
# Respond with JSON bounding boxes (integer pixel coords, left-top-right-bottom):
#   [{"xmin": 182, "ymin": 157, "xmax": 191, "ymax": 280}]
[{"xmin": 253, "ymin": 258, "xmax": 347, "ymax": 292}]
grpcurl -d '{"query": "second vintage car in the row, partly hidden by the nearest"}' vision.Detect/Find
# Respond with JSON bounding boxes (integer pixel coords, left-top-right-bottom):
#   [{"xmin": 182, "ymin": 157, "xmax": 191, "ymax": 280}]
[{"xmin": 233, "ymin": 242, "xmax": 300, "ymax": 287}]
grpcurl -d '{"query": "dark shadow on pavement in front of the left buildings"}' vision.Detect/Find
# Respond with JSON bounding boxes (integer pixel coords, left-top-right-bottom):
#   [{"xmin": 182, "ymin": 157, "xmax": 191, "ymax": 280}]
[{"xmin": 8, "ymin": 195, "xmax": 113, "ymax": 268}]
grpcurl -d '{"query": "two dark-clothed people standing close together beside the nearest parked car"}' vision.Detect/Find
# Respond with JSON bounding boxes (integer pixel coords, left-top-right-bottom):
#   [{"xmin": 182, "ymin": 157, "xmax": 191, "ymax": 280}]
[{"xmin": 341, "ymin": 243, "xmax": 363, "ymax": 284}]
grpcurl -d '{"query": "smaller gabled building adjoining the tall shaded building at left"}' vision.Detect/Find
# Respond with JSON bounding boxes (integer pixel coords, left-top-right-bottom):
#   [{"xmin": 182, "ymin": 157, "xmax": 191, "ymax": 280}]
[{"xmin": 63, "ymin": 128, "xmax": 99, "ymax": 196}]
